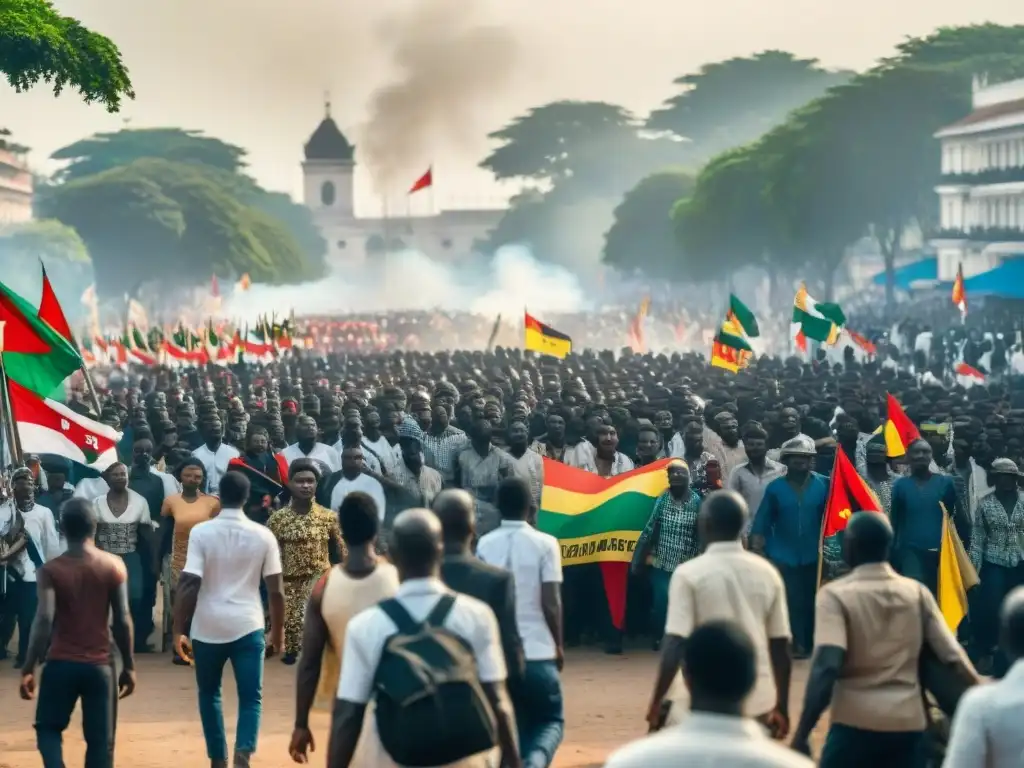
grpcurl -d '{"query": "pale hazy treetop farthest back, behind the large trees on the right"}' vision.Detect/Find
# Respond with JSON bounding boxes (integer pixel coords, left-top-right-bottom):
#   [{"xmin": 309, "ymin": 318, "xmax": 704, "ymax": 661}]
[{"xmin": 647, "ymin": 50, "xmax": 852, "ymax": 159}]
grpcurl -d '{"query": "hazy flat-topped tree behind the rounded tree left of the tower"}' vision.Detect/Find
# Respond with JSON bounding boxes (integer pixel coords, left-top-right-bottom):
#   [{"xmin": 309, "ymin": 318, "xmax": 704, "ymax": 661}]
[{"xmin": 50, "ymin": 128, "xmax": 327, "ymax": 280}]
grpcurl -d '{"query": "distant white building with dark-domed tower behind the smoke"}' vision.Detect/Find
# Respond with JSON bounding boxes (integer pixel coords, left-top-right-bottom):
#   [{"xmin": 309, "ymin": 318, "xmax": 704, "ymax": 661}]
[{"xmin": 302, "ymin": 103, "xmax": 505, "ymax": 265}]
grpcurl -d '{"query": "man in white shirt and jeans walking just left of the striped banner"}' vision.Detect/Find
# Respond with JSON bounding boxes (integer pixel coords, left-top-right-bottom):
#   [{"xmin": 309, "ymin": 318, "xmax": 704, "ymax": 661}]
[{"xmin": 476, "ymin": 477, "xmax": 565, "ymax": 768}]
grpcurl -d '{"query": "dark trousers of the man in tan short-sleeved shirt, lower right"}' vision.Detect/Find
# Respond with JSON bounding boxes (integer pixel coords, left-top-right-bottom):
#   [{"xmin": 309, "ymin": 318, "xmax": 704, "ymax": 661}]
[{"xmin": 818, "ymin": 723, "xmax": 927, "ymax": 768}]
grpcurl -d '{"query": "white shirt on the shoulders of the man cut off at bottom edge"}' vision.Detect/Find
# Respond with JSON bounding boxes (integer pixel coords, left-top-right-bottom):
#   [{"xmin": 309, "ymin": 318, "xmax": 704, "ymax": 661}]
[{"xmin": 604, "ymin": 712, "xmax": 814, "ymax": 768}]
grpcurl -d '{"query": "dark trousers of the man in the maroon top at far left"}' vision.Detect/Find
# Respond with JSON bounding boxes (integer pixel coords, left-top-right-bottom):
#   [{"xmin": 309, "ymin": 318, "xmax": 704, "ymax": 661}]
[{"xmin": 36, "ymin": 660, "xmax": 118, "ymax": 768}]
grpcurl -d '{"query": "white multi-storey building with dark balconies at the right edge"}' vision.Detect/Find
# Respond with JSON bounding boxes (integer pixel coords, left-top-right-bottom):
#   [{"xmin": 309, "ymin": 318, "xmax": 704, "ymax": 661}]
[{"xmin": 932, "ymin": 78, "xmax": 1024, "ymax": 281}]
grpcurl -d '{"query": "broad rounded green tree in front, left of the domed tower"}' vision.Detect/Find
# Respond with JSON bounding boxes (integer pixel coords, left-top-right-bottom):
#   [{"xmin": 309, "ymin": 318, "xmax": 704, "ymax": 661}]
[{"xmin": 37, "ymin": 159, "xmax": 322, "ymax": 296}]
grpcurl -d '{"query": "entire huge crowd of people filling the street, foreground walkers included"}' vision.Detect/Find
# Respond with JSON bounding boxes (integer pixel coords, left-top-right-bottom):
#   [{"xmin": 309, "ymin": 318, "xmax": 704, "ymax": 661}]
[{"xmin": 0, "ymin": 303, "xmax": 1024, "ymax": 768}]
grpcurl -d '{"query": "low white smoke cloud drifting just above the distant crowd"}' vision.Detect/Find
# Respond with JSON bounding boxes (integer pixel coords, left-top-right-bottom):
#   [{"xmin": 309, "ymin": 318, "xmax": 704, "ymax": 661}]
[{"xmin": 223, "ymin": 246, "xmax": 588, "ymax": 321}]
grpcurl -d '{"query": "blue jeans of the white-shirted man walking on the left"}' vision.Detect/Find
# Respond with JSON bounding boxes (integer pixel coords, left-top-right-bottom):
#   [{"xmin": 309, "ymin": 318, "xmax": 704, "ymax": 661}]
[{"xmin": 193, "ymin": 629, "xmax": 266, "ymax": 760}]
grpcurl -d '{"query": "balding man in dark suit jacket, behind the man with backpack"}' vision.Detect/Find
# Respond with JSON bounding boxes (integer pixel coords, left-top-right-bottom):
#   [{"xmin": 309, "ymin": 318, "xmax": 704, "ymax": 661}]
[{"xmin": 433, "ymin": 488, "xmax": 526, "ymax": 693}]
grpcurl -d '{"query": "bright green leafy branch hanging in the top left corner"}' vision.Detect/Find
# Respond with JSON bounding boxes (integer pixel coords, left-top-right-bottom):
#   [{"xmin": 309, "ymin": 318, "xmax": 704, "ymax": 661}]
[{"xmin": 0, "ymin": 0, "xmax": 135, "ymax": 112}]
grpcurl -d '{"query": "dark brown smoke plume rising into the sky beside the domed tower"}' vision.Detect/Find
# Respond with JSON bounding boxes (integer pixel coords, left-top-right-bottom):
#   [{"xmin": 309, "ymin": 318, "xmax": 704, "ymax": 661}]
[{"xmin": 358, "ymin": 0, "xmax": 517, "ymax": 193}]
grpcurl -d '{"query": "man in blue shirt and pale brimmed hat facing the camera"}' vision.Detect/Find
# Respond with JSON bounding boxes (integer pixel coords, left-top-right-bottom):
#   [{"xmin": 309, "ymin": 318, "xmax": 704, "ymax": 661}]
[{"xmin": 751, "ymin": 435, "xmax": 828, "ymax": 658}]
